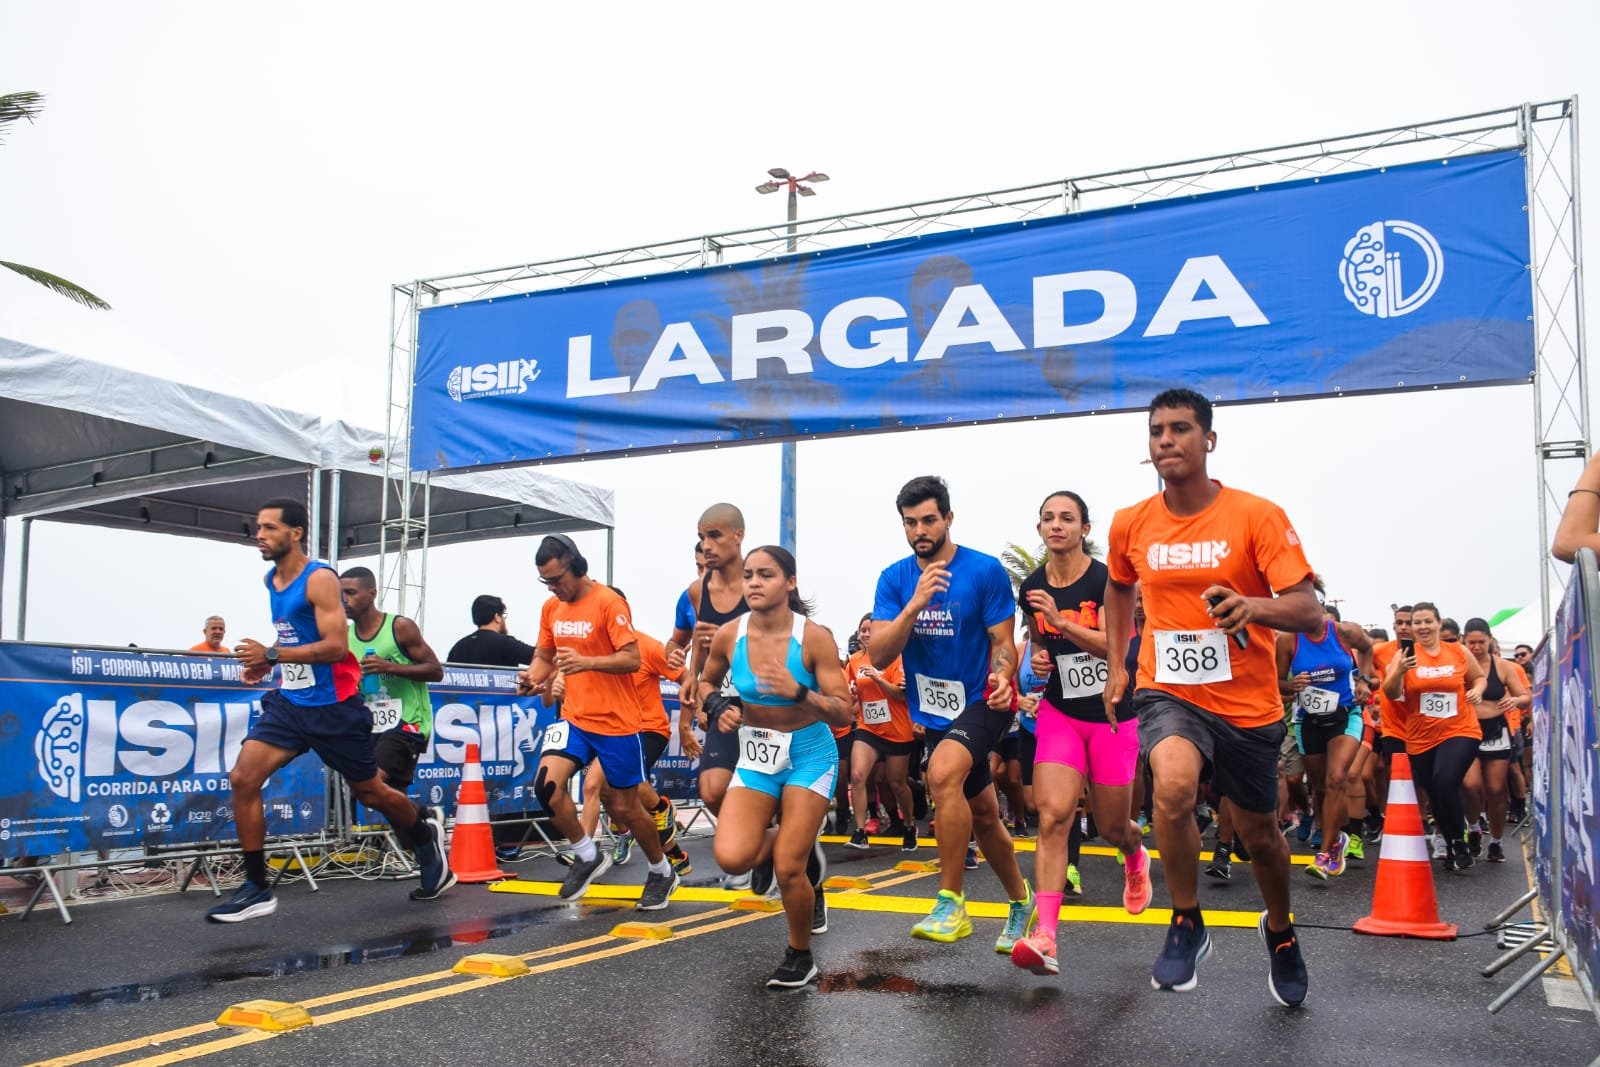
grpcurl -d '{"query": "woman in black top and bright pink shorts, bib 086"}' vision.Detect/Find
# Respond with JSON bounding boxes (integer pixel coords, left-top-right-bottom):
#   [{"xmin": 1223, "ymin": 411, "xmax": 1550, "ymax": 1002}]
[{"xmin": 1011, "ymin": 491, "xmax": 1150, "ymax": 974}]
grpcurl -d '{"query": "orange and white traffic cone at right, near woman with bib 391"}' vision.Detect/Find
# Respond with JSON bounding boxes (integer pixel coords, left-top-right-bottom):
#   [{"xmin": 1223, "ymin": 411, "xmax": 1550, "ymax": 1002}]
[{"xmin": 1355, "ymin": 752, "xmax": 1456, "ymax": 941}]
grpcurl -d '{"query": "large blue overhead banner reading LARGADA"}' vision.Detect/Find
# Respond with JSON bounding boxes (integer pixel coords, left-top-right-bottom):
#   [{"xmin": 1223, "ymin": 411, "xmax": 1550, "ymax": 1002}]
[{"xmin": 411, "ymin": 150, "xmax": 1534, "ymax": 470}]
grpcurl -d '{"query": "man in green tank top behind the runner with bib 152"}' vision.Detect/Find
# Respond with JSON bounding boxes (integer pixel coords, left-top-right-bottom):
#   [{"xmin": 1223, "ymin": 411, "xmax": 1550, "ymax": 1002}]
[{"xmin": 339, "ymin": 566, "xmax": 445, "ymax": 792}]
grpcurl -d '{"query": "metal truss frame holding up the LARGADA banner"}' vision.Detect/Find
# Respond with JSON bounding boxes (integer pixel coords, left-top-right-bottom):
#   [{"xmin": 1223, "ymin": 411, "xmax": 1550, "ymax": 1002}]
[{"xmin": 384, "ymin": 98, "xmax": 1589, "ymax": 624}]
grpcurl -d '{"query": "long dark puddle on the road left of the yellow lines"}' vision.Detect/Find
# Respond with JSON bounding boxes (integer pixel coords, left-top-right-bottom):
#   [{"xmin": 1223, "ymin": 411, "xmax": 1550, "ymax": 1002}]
[{"xmin": 0, "ymin": 909, "xmax": 573, "ymax": 1019}]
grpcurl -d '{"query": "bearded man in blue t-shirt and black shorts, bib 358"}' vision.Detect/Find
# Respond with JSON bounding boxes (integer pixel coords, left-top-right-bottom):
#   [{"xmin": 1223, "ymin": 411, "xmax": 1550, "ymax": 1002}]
[{"xmin": 867, "ymin": 475, "xmax": 1034, "ymax": 955}]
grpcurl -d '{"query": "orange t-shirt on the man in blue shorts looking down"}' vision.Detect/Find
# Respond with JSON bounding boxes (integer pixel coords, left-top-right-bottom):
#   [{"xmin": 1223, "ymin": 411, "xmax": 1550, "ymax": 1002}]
[{"xmin": 539, "ymin": 584, "xmax": 642, "ymax": 736}]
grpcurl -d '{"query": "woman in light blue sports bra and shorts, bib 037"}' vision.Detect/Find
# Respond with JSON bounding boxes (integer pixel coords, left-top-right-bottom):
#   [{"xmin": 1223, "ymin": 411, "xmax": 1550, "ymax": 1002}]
[{"xmin": 701, "ymin": 545, "xmax": 854, "ymax": 989}]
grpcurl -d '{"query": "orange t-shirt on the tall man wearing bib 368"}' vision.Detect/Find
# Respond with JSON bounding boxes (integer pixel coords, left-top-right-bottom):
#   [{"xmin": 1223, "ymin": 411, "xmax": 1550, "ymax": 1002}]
[{"xmin": 1106, "ymin": 483, "xmax": 1312, "ymax": 729}]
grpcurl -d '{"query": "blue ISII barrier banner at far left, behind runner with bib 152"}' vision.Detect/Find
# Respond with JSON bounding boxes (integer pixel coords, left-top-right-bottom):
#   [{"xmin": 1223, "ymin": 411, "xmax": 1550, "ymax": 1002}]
[{"xmin": 0, "ymin": 641, "xmax": 326, "ymax": 859}]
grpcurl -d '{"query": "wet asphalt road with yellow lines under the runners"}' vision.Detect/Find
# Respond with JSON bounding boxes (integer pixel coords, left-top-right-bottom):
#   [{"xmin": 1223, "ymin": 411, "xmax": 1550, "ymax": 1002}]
[{"xmin": 0, "ymin": 840, "xmax": 1600, "ymax": 1065}]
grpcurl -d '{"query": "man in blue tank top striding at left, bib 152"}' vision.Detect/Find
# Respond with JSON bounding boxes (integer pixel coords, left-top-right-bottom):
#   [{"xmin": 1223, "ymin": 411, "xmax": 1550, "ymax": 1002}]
[{"xmin": 206, "ymin": 499, "xmax": 456, "ymax": 923}]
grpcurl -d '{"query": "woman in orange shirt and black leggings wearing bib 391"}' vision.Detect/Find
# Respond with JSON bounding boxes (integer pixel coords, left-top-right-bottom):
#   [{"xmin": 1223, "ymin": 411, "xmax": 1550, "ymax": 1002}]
[{"xmin": 1382, "ymin": 600, "xmax": 1488, "ymax": 870}]
